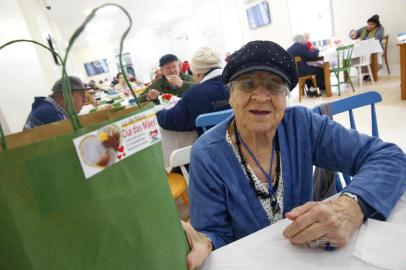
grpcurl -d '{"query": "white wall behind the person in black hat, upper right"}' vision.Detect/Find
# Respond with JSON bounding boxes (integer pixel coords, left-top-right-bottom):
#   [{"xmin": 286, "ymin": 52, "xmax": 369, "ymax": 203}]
[{"xmin": 331, "ymin": 0, "xmax": 406, "ymax": 74}]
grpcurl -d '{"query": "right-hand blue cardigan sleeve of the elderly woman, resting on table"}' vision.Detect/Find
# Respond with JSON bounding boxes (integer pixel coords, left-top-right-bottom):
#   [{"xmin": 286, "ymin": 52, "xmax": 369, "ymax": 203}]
[{"xmin": 306, "ymin": 110, "xmax": 406, "ymax": 219}]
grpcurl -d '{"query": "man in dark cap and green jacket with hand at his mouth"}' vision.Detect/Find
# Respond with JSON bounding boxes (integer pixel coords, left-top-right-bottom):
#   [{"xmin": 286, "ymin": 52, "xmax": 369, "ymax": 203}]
[{"xmin": 138, "ymin": 54, "xmax": 194, "ymax": 102}]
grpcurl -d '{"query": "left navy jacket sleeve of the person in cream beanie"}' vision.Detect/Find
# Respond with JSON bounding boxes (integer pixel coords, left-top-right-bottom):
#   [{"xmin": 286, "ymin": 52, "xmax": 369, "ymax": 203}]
[{"xmin": 157, "ymin": 98, "xmax": 195, "ymax": 131}]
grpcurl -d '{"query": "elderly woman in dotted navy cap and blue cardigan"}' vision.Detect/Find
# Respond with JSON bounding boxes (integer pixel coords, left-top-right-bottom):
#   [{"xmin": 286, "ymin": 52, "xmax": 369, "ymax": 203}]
[{"xmin": 183, "ymin": 41, "xmax": 406, "ymax": 269}]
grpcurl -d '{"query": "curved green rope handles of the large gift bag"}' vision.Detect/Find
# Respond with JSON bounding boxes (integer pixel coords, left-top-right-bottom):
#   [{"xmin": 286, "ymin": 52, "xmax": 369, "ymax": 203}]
[{"xmin": 0, "ymin": 3, "xmax": 141, "ymax": 150}]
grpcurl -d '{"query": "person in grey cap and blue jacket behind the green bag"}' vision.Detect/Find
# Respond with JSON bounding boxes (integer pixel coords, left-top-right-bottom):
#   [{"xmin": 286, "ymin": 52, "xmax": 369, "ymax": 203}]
[{"xmin": 24, "ymin": 76, "xmax": 90, "ymax": 130}]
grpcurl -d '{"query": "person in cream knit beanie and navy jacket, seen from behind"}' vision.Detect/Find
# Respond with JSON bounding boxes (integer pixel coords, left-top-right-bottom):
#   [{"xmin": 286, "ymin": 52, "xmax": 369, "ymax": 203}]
[{"xmin": 157, "ymin": 47, "xmax": 230, "ymax": 134}]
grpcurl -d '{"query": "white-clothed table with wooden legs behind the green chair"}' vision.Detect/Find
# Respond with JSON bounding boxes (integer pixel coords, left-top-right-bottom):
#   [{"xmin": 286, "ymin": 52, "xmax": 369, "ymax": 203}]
[{"xmin": 320, "ymin": 39, "xmax": 383, "ymax": 97}]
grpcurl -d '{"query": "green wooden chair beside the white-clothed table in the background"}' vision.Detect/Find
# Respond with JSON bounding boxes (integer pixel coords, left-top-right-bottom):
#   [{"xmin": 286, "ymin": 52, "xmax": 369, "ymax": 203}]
[{"xmin": 330, "ymin": 44, "xmax": 355, "ymax": 96}]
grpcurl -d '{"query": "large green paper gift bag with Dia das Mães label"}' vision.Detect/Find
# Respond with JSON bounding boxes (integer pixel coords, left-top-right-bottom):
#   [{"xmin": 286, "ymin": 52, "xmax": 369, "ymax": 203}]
[{"xmin": 0, "ymin": 3, "xmax": 188, "ymax": 270}]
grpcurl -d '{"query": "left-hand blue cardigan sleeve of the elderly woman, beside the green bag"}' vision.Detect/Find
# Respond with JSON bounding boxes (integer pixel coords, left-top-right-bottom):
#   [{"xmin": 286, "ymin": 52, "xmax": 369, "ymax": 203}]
[{"xmin": 189, "ymin": 148, "xmax": 233, "ymax": 248}]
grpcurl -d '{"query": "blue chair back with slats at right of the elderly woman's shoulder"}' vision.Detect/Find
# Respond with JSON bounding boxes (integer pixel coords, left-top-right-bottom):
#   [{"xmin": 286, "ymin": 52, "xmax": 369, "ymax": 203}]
[{"xmin": 313, "ymin": 91, "xmax": 382, "ymax": 191}]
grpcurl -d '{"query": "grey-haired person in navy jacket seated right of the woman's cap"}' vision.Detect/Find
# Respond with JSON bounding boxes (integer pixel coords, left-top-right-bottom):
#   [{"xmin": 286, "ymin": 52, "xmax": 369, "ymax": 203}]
[{"xmin": 287, "ymin": 35, "xmax": 326, "ymax": 96}]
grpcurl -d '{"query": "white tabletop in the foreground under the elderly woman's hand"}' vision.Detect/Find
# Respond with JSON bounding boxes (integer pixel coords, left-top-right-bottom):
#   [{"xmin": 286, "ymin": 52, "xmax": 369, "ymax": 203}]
[{"xmin": 201, "ymin": 194, "xmax": 406, "ymax": 270}]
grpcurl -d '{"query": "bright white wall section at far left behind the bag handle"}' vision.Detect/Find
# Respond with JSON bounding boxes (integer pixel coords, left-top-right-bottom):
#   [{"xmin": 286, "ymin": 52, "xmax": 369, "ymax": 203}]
[{"xmin": 0, "ymin": 0, "xmax": 51, "ymax": 132}]
